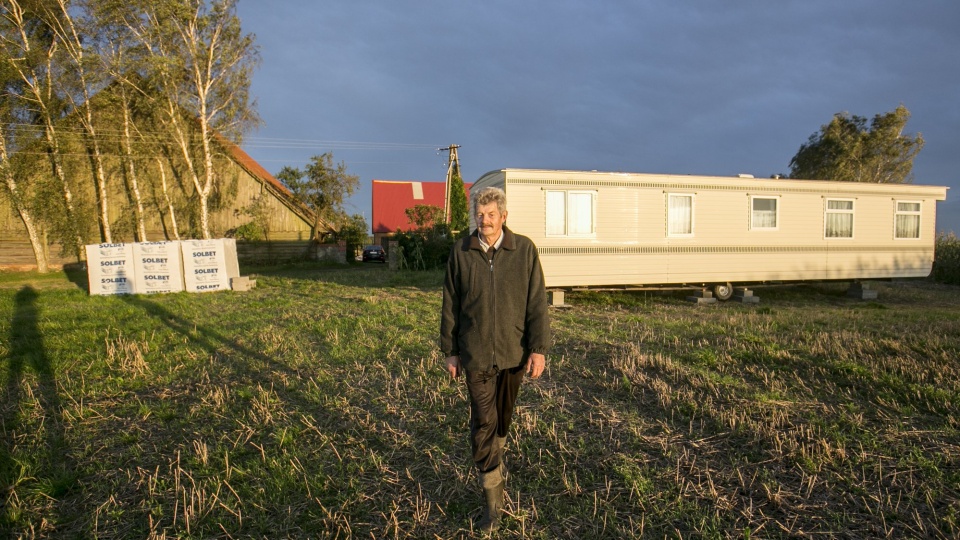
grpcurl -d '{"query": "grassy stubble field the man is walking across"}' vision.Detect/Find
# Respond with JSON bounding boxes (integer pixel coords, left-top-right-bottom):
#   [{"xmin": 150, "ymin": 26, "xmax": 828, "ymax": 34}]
[{"xmin": 0, "ymin": 267, "xmax": 960, "ymax": 539}]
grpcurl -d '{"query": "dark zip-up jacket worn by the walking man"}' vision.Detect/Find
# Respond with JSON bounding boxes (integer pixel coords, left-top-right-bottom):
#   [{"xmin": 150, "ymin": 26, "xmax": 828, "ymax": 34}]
[{"xmin": 440, "ymin": 227, "xmax": 550, "ymax": 371}]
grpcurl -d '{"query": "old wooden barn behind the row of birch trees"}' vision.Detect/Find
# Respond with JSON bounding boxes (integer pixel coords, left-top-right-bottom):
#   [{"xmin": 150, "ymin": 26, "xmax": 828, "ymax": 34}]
[{"xmin": 0, "ymin": 137, "xmax": 329, "ymax": 266}]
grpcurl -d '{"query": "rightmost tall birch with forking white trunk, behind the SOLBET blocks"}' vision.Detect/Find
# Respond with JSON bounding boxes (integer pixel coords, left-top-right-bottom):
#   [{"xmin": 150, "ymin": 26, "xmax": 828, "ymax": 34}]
[{"xmin": 124, "ymin": 0, "xmax": 259, "ymax": 238}]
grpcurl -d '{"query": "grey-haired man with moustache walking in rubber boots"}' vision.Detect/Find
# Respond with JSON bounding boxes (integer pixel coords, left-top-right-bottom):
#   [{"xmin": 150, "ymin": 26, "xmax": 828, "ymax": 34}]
[{"xmin": 440, "ymin": 188, "xmax": 550, "ymax": 531}]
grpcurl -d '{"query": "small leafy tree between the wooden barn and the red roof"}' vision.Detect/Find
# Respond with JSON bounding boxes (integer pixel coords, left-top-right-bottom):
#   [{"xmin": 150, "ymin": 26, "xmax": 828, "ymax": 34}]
[{"xmin": 277, "ymin": 152, "xmax": 360, "ymax": 241}]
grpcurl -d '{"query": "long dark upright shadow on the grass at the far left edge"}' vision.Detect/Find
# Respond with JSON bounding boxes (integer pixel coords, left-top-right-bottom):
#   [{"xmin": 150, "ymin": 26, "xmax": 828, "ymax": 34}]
[{"xmin": 0, "ymin": 286, "xmax": 77, "ymax": 525}]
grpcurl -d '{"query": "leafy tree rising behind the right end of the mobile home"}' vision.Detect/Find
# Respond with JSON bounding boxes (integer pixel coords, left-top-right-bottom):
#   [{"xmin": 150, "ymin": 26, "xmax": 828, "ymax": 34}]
[{"xmin": 790, "ymin": 105, "xmax": 924, "ymax": 183}]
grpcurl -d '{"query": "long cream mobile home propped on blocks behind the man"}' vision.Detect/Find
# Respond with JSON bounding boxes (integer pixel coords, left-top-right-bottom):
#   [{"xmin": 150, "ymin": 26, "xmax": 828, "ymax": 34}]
[{"xmin": 471, "ymin": 169, "xmax": 947, "ymax": 299}]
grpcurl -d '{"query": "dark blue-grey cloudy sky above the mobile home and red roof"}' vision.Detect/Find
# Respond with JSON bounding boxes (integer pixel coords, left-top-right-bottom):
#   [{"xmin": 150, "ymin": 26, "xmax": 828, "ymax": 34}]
[{"xmin": 239, "ymin": 0, "xmax": 960, "ymax": 233}]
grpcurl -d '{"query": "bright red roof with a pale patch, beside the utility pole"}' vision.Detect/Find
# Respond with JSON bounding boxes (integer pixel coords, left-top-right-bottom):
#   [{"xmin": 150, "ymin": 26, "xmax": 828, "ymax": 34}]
[{"xmin": 372, "ymin": 180, "xmax": 472, "ymax": 234}]
